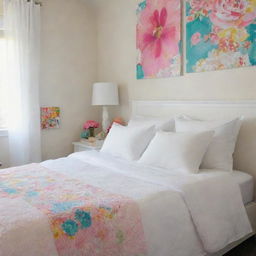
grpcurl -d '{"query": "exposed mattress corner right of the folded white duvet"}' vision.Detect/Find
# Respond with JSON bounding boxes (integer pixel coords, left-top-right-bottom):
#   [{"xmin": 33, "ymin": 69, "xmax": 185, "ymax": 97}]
[{"xmin": 231, "ymin": 171, "xmax": 254, "ymax": 205}]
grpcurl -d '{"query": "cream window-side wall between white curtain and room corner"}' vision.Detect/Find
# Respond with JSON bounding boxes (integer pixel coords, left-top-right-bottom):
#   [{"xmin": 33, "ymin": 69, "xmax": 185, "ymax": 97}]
[{"xmin": 0, "ymin": 0, "xmax": 100, "ymax": 167}]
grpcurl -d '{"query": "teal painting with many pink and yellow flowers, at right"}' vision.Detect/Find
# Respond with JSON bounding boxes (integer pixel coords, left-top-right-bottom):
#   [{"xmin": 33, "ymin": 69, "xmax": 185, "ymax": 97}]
[{"xmin": 186, "ymin": 0, "xmax": 256, "ymax": 72}]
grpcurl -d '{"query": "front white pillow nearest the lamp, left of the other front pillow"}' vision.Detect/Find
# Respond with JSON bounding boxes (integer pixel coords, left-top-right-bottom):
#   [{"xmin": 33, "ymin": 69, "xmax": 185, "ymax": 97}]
[{"xmin": 101, "ymin": 123, "xmax": 155, "ymax": 160}]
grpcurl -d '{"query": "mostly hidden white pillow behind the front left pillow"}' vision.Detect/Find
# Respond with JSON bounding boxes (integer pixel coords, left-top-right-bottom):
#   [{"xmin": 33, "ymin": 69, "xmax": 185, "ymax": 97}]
[{"xmin": 128, "ymin": 116, "xmax": 175, "ymax": 132}]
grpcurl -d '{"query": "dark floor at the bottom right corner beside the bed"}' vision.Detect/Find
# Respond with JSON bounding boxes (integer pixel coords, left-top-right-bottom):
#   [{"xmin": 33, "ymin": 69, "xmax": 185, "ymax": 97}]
[{"xmin": 225, "ymin": 237, "xmax": 256, "ymax": 256}]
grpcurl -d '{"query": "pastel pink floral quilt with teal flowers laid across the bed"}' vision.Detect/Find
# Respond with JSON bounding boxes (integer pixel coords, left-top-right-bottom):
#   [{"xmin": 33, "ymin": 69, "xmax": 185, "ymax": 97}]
[{"xmin": 0, "ymin": 164, "xmax": 146, "ymax": 256}]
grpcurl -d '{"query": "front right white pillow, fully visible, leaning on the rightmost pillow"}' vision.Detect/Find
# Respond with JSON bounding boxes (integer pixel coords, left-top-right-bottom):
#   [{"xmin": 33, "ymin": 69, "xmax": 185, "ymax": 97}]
[{"xmin": 139, "ymin": 131, "xmax": 214, "ymax": 173}]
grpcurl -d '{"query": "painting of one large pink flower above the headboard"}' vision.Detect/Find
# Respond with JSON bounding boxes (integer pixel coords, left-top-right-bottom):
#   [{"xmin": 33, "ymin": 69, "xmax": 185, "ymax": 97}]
[{"xmin": 137, "ymin": 0, "xmax": 181, "ymax": 79}]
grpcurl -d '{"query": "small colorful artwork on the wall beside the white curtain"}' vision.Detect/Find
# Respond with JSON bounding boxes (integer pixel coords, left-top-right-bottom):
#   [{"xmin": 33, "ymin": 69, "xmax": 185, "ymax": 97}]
[{"xmin": 41, "ymin": 107, "xmax": 60, "ymax": 129}]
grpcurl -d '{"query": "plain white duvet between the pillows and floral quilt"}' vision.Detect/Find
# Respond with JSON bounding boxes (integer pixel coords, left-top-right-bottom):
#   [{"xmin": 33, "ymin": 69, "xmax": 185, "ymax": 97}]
[{"xmin": 42, "ymin": 151, "xmax": 251, "ymax": 256}]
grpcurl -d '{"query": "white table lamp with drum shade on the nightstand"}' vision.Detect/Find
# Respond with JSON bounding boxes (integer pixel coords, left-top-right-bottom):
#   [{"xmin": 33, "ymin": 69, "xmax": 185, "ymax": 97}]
[{"xmin": 92, "ymin": 83, "xmax": 119, "ymax": 133}]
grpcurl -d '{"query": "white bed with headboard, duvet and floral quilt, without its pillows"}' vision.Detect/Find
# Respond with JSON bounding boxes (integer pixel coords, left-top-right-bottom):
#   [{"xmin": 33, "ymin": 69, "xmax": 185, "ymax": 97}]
[{"xmin": 0, "ymin": 101, "xmax": 256, "ymax": 256}]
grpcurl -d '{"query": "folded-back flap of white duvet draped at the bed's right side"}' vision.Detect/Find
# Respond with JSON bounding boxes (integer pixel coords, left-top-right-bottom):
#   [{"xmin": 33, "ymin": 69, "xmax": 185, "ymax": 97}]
[{"xmin": 183, "ymin": 175, "xmax": 252, "ymax": 253}]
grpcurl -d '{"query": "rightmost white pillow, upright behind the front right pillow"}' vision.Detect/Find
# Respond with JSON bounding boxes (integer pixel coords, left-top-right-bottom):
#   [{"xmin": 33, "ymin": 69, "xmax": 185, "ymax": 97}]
[{"xmin": 175, "ymin": 117, "xmax": 242, "ymax": 171}]
